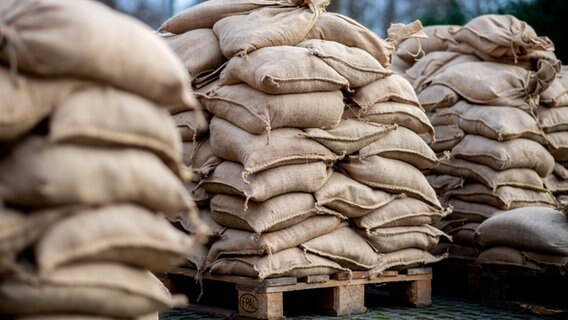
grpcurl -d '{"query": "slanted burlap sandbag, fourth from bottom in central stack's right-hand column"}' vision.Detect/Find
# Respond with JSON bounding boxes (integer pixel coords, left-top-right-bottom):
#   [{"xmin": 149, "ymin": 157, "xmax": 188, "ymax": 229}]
[{"xmin": 339, "ymin": 156, "xmax": 441, "ymax": 208}]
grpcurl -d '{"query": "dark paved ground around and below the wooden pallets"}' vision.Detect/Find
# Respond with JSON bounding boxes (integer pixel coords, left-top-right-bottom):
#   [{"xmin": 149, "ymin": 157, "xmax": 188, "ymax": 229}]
[{"xmin": 160, "ymin": 296, "xmax": 552, "ymax": 320}]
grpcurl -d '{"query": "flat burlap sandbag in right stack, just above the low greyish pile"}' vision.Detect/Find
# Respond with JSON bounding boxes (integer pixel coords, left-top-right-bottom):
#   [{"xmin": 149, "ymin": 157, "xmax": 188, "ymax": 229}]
[{"xmin": 446, "ymin": 184, "xmax": 557, "ymax": 210}]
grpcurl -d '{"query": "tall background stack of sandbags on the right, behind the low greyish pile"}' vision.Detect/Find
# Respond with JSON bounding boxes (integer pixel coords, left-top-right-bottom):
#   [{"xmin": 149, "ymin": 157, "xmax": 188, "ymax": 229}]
[{"xmin": 390, "ymin": 15, "xmax": 560, "ymax": 260}]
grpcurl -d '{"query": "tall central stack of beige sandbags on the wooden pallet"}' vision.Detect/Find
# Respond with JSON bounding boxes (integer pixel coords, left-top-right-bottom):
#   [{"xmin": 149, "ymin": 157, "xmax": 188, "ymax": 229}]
[{"xmin": 160, "ymin": 0, "xmax": 447, "ymax": 279}]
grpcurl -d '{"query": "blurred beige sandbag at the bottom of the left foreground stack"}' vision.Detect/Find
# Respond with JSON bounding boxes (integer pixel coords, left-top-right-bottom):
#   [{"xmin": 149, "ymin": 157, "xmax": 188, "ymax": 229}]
[{"xmin": 0, "ymin": 262, "xmax": 187, "ymax": 319}]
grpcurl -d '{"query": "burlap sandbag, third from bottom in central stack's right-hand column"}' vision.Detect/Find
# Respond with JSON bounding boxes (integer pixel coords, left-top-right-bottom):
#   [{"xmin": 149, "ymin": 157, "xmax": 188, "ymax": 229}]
[{"xmin": 353, "ymin": 198, "xmax": 451, "ymax": 229}]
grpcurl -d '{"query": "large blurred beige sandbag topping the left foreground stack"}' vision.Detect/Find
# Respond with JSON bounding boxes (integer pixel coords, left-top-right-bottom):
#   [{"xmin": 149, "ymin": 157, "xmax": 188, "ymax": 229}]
[{"xmin": 0, "ymin": 0, "xmax": 198, "ymax": 111}]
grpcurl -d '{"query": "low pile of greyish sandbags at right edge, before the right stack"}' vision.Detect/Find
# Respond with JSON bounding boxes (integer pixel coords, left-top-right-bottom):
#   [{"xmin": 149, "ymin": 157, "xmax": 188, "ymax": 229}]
[{"xmin": 476, "ymin": 207, "xmax": 568, "ymax": 274}]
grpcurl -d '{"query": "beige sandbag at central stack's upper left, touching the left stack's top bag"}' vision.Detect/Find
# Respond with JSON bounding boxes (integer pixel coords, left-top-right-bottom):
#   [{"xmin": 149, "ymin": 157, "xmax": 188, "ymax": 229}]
[{"xmin": 159, "ymin": 28, "xmax": 226, "ymax": 82}]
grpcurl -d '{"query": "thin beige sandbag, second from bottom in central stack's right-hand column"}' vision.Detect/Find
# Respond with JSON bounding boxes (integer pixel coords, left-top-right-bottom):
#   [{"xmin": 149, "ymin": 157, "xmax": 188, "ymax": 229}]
[{"xmin": 359, "ymin": 225, "xmax": 451, "ymax": 253}]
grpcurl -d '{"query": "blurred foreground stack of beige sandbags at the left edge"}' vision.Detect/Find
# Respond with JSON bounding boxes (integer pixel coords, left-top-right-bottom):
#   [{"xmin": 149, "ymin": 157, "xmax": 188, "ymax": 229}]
[{"xmin": 0, "ymin": 0, "xmax": 204, "ymax": 319}]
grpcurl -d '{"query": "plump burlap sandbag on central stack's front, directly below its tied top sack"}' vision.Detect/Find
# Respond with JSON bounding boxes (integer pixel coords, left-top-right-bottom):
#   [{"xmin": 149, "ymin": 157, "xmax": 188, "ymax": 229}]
[{"xmin": 221, "ymin": 46, "xmax": 349, "ymax": 94}]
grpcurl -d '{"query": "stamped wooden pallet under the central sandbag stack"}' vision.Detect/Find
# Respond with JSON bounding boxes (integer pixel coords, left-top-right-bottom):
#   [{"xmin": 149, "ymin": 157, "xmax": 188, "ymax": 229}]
[{"xmin": 168, "ymin": 268, "xmax": 432, "ymax": 319}]
